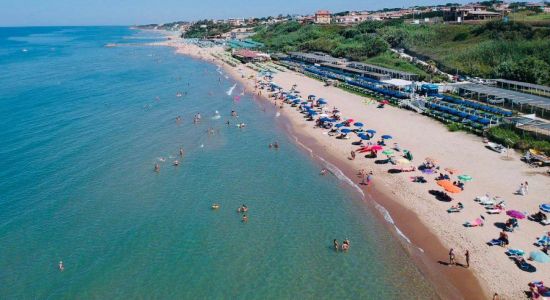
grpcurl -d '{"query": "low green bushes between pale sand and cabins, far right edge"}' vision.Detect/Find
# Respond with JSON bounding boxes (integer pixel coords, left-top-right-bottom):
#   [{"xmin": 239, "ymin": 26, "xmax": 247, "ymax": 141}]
[{"xmin": 488, "ymin": 126, "xmax": 550, "ymax": 155}]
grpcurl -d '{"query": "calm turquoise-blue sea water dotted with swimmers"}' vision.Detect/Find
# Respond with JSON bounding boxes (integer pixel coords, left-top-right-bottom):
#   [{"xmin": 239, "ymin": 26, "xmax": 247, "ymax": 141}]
[{"xmin": 0, "ymin": 27, "xmax": 434, "ymax": 299}]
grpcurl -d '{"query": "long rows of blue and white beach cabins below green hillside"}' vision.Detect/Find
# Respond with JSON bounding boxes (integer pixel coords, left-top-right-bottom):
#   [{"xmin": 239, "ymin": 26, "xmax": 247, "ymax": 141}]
[{"xmin": 275, "ymin": 52, "xmax": 550, "ymax": 138}]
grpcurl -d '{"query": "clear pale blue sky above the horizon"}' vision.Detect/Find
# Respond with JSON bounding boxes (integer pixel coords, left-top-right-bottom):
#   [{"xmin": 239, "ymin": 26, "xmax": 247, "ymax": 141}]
[{"xmin": 0, "ymin": 0, "xmax": 465, "ymax": 27}]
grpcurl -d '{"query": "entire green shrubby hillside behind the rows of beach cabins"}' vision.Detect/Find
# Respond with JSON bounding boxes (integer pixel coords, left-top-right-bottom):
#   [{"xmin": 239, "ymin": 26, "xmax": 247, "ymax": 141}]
[{"xmin": 254, "ymin": 18, "xmax": 550, "ymax": 85}]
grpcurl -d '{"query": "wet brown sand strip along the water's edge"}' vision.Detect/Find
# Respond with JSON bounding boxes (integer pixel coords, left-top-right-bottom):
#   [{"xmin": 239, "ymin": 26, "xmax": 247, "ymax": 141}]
[{"xmin": 153, "ymin": 34, "xmax": 490, "ymax": 300}]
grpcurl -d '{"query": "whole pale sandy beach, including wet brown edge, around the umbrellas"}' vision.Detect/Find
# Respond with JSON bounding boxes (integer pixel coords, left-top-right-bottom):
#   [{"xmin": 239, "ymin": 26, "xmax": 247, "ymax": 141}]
[{"xmin": 156, "ymin": 34, "xmax": 550, "ymax": 299}]
